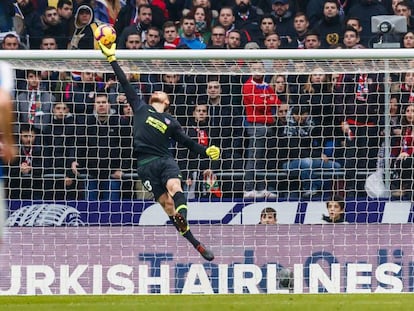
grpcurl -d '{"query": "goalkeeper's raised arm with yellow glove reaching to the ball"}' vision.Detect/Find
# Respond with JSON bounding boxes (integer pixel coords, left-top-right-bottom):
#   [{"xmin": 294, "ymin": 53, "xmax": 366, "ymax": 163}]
[{"xmin": 98, "ymin": 41, "xmax": 141, "ymax": 110}]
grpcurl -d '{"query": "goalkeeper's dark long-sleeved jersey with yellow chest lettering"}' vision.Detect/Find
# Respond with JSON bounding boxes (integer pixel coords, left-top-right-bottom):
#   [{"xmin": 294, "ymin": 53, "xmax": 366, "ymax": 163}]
[{"xmin": 111, "ymin": 61, "xmax": 207, "ymax": 165}]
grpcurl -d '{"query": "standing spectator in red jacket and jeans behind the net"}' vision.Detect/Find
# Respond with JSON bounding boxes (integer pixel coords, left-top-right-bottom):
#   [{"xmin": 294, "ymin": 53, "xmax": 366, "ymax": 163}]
[{"xmin": 242, "ymin": 61, "xmax": 282, "ymax": 199}]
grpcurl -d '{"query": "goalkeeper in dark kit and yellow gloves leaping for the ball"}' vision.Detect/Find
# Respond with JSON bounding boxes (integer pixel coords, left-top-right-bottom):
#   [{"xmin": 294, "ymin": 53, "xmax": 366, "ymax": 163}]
[{"xmin": 99, "ymin": 42, "xmax": 220, "ymax": 261}]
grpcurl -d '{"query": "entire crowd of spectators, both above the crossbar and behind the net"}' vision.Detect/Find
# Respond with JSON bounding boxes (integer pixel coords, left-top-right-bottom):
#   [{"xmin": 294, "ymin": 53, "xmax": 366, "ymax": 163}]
[{"xmin": 0, "ymin": 0, "xmax": 414, "ymax": 200}]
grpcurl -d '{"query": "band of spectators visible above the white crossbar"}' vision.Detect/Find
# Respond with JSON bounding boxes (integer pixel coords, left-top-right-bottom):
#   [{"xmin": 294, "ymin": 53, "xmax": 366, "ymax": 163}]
[{"xmin": 0, "ymin": 0, "xmax": 414, "ymax": 49}]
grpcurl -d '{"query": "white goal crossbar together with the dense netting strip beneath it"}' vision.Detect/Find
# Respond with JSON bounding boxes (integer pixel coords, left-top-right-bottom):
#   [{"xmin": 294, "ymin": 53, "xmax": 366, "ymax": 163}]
[{"xmin": 0, "ymin": 49, "xmax": 414, "ymax": 75}]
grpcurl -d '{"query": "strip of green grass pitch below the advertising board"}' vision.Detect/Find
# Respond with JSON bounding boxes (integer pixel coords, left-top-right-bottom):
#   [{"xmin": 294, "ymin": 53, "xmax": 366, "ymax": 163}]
[{"xmin": 0, "ymin": 294, "xmax": 414, "ymax": 311}]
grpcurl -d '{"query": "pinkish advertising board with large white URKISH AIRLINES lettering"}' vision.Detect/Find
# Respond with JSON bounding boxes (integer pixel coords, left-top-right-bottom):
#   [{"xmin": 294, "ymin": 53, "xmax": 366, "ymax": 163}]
[{"xmin": 0, "ymin": 224, "xmax": 414, "ymax": 295}]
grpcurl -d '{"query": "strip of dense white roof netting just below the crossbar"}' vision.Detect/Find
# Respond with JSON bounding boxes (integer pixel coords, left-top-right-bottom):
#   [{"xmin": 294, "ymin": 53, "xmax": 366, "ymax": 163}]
[{"xmin": 6, "ymin": 58, "xmax": 414, "ymax": 75}]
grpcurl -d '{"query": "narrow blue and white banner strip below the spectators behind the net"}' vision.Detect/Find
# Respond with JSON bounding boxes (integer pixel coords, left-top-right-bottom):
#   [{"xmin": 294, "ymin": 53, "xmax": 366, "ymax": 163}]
[{"xmin": 8, "ymin": 200, "xmax": 414, "ymax": 226}]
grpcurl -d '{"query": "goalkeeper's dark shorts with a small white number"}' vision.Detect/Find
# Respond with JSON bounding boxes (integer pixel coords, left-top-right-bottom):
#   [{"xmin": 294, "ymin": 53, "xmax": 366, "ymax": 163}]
[{"xmin": 138, "ymin": 157, "xmax": 182, "ymax": 201}]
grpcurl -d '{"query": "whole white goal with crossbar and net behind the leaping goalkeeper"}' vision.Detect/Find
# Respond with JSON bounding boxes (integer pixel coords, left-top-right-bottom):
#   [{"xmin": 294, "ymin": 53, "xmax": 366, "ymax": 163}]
[{"xmin": 0, "ymin": 50, "xmax": 414, "ymax": 294}]
